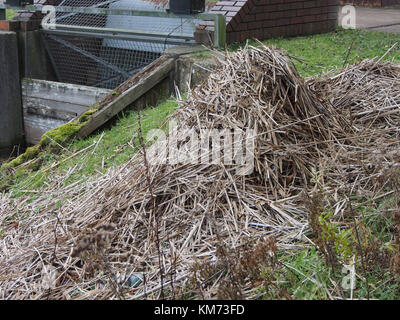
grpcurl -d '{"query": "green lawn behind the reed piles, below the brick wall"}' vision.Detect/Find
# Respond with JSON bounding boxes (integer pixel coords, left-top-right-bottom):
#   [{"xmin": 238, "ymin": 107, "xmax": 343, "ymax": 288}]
[{"xmin": 230, "ymin": 29, "xmax": 400, "ymax": 77}]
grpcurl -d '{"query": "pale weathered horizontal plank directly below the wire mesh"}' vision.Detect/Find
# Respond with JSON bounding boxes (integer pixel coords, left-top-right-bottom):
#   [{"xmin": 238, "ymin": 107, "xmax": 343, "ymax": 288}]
[{"xmin": 22, "ymin": 79, "xmax": 111, "ymax": 107}]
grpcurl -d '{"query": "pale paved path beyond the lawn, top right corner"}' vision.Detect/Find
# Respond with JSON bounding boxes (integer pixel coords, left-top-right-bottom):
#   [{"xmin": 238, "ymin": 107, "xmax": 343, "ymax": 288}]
[{"xmin": 339, "ymin": 7, "xmax": 400, "ymax": 33}]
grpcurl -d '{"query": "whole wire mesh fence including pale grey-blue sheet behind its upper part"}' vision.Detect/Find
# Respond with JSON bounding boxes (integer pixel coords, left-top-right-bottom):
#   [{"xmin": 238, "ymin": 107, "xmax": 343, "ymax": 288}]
[{"xmin": 43, "ymin": 0, "xmax": 200, "ymax": 89}]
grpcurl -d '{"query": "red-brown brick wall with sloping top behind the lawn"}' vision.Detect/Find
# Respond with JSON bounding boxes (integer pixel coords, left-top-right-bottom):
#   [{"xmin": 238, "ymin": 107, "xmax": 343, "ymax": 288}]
[{"xmin": 195, "ymin": 0, "xmax": 338, "ymax": 43}]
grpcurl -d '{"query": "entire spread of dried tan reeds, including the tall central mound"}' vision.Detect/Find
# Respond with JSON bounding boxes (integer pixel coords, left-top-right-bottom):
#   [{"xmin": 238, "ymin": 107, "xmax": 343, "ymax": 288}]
[{"xmin": 0, "ymin": 43, "xmax": 400, "ymax": 299}]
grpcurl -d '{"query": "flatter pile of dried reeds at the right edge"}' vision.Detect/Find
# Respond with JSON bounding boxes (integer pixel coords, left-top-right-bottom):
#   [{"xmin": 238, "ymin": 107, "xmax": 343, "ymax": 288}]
[{"xmin": 308, "ymin": 58, "xmax": 400, "ymax": 199}]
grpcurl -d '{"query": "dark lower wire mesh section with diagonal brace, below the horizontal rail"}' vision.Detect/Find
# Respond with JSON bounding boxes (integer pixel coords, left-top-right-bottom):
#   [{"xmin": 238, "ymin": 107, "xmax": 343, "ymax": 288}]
[{"xmin": 45, "ymin": 34, "xmax": 160, "ymax": 89}]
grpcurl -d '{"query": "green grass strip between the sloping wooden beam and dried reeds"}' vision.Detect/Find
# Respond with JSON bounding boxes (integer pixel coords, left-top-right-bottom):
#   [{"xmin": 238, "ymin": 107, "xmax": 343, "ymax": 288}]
[{"xmin": 6, "ymin": 100, "xmax": 177, "ymax": 197}]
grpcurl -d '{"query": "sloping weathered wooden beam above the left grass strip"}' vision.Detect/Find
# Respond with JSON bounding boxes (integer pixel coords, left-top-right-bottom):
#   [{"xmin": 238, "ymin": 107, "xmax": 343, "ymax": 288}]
[{"xmin": 78, "ymin": 57, "xmax": 175, "ymax": 138}]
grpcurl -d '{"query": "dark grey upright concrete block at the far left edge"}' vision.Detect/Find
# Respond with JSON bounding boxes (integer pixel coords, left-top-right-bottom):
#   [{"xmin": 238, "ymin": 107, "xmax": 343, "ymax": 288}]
[{"xmin": 0, "ymin": 31, "xmax": 24, "ymax": 153}]
